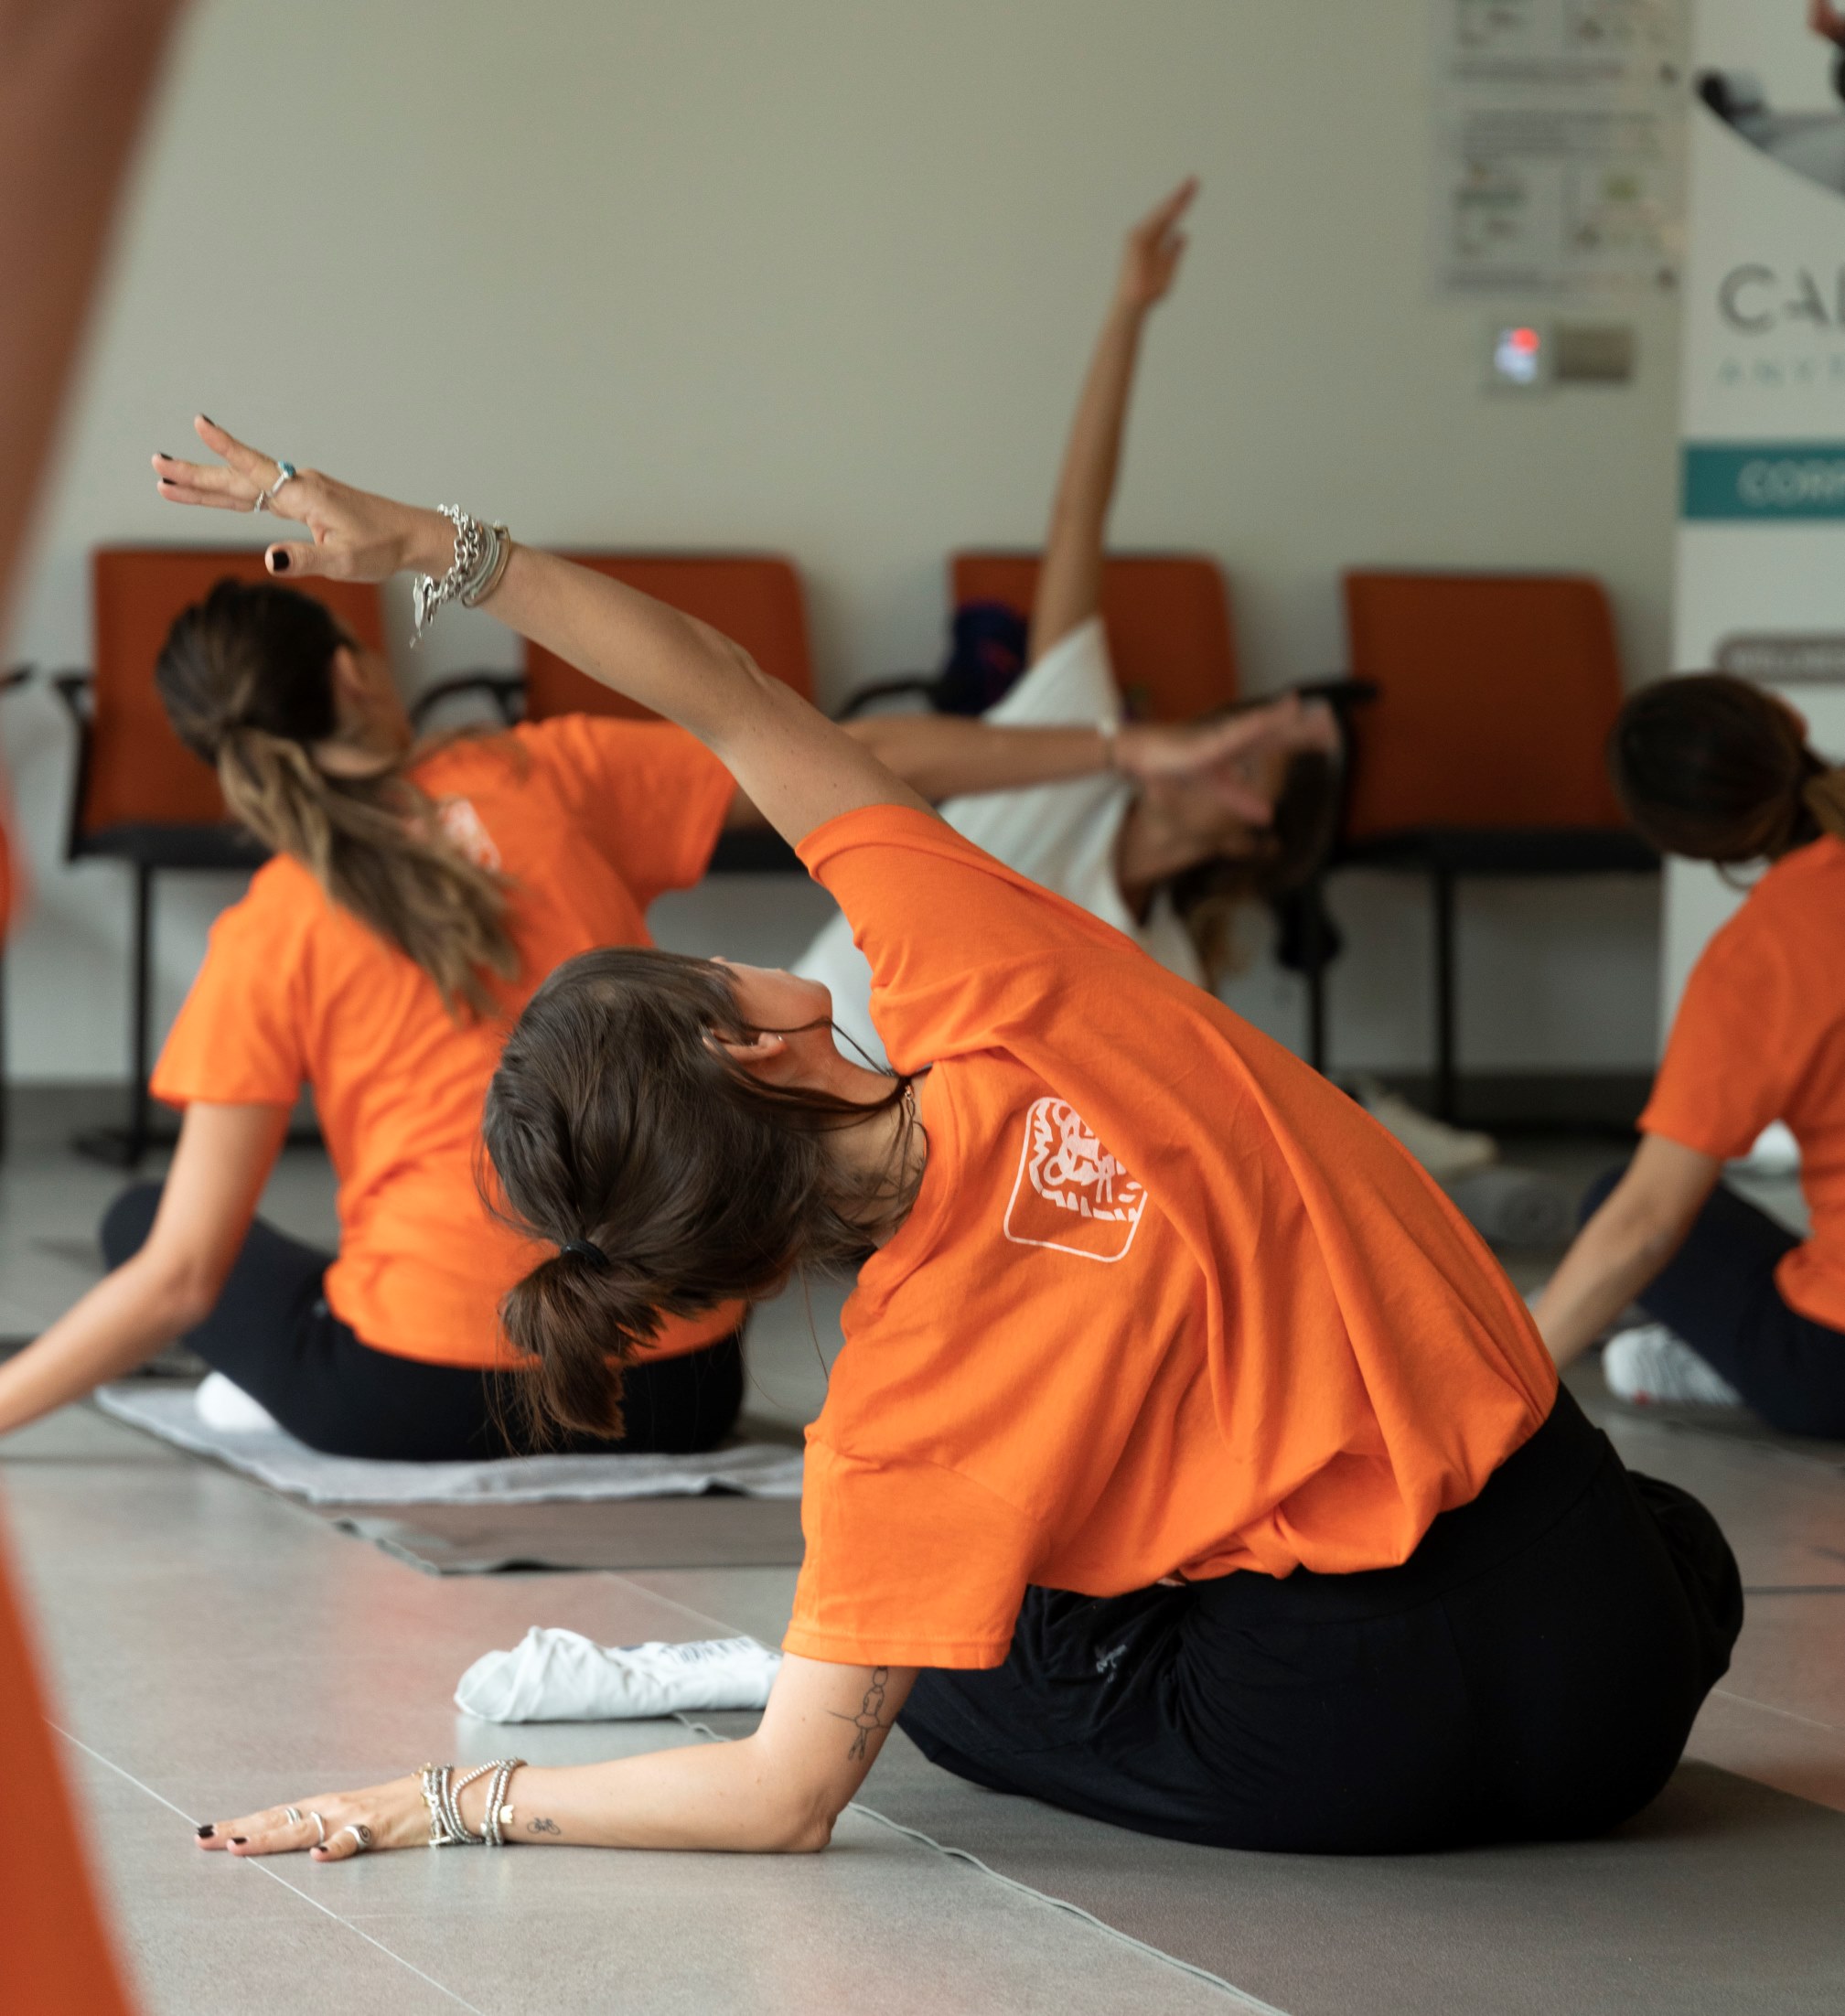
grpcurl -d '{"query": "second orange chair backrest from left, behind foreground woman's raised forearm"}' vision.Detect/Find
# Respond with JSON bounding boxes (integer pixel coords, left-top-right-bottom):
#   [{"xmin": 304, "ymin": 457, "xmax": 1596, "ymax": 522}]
[{"xmin": 524, "ymin": 552, "xmax": 812, "ymax": 722}]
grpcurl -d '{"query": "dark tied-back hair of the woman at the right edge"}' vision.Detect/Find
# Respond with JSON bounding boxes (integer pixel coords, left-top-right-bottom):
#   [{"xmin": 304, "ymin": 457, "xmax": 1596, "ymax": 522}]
[{"xmin": 1607, "ymin": 671, "xmax": 1845, "ymax": 867}]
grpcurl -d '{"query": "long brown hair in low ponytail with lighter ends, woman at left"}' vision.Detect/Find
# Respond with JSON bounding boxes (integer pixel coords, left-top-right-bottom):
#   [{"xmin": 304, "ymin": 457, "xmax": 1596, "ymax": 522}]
[{"xmin": 154, "ymin": 581, "xmax": 519, "ymax": 1020}]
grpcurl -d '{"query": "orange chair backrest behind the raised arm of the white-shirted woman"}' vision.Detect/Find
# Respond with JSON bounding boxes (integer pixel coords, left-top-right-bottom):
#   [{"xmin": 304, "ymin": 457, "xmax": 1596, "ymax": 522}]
[{"xmin": 948, "ymin": 552, "xmax": 1236, "ymax": 722}]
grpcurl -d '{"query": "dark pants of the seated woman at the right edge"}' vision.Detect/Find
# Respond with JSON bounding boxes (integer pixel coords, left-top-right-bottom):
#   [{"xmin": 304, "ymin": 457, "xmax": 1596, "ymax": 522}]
[{"xmin": 1582, "ymin": 1169, "xmax": 1845, "ymax": 1437}]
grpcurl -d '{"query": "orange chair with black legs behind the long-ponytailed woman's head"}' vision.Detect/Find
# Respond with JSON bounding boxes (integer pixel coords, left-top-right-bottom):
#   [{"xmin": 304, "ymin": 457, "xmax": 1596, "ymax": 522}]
[{"xmin": 52, "ymin": 546, "xmax": 385, "ymax": 1167}]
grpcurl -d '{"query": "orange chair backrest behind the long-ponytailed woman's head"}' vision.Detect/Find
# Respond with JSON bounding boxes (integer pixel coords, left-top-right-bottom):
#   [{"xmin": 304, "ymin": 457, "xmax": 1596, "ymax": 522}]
[{"xmin": 88, "ymin": 546, "xmax": 385, "ymax": 834}]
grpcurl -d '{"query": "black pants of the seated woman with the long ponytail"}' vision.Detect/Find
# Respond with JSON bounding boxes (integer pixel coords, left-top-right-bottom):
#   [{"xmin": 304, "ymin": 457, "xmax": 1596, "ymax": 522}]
[{"xmin": 101, "ymin": 1184, "xmax": 744, "ymax": 1464}]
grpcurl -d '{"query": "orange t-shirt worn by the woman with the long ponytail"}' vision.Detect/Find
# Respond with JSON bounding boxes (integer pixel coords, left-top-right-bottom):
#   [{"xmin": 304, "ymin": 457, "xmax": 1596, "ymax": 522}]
[{"xmin": 154, "ymin": 715, "xmax": 740, "ymax": 1365}]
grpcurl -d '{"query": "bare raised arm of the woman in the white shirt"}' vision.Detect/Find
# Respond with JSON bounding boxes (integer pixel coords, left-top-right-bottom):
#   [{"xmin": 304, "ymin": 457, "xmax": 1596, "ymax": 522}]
[{"xmin": 1030, "ymin": 179, "xmax": 1197, "ymax": 663}]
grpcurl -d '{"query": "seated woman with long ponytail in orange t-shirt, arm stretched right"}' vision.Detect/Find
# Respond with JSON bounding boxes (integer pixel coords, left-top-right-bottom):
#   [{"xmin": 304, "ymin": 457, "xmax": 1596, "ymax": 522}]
[{"xmin": 0, "ymin": 469, "xmax": 1271, "ymax": 1462}]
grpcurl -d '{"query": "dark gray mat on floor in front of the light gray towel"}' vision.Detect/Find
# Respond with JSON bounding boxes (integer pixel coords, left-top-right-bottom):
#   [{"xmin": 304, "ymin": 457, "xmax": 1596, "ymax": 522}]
[{"xmin": 328, "ymin": 1494, "xmax": 800, "ymax": 1574}]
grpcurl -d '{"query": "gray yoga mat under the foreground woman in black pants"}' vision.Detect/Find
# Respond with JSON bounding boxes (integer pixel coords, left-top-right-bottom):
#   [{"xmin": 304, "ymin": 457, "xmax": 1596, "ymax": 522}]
[{"xmin": 839, "ymin": 1750, "xmax": 1845, "ymax": 2016}]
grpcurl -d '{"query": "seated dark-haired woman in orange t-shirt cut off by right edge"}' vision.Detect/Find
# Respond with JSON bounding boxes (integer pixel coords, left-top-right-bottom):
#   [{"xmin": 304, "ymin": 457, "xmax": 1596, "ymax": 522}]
[{"xmin": 1537, "ymin": 673, "xmax": 1845, "ymax": 1435}]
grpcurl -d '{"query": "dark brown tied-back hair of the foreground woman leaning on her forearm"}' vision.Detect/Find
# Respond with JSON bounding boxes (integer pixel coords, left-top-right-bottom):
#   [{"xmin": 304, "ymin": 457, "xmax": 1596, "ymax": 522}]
[{"xmin": 482, "ymin": 948, "xmax": 914, "ymax": 1442}]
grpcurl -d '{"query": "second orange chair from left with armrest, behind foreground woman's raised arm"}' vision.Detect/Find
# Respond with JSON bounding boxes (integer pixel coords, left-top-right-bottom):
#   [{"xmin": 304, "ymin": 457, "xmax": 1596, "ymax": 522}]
[{"xmin": 413, "ymin": 552, "xmax": 815, "ymax": 873}]
